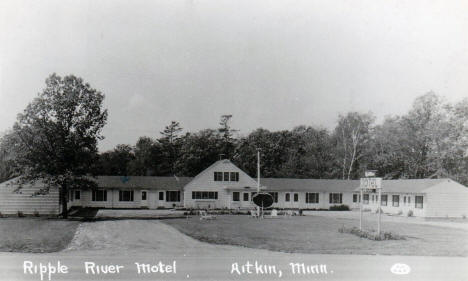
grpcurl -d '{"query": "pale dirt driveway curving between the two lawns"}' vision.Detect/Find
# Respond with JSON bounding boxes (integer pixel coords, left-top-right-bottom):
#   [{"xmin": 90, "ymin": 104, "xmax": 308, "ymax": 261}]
[{"xmin": 63, "ymin": 220, "xmax": 260, "ymax": 256}]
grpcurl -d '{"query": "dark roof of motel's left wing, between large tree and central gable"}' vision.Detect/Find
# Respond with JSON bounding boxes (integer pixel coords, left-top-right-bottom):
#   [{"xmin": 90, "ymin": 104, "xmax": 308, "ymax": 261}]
[{"xmin": 96, "ymin": 176, "xmax": 192, "ymax": 190}]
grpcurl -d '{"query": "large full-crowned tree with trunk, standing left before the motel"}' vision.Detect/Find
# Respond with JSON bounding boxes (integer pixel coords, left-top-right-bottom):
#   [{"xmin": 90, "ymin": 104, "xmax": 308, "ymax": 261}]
[{"xmin": 13, "ymin": 74, "xmax": 107, "ymax": 218}]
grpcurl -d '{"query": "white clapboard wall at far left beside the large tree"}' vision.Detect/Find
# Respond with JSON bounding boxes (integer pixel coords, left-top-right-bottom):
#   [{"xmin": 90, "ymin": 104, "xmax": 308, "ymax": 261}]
[{"xmin": 0, "ymin": 181, "xmax": 60, "ymax": 215}]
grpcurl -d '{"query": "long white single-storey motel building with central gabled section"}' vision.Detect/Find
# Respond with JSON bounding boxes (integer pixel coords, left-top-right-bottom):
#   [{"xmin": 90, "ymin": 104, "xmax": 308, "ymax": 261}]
[{"xmin": 0, "ymin": 159, "xmax": 468, "ymax": 218}]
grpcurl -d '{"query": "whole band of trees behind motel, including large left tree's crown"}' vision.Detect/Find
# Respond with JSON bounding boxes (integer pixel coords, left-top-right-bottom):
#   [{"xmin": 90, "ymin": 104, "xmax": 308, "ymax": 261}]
[{"xmin": 0, "ymin": 74, "xmax": 468, "ymax": 184}]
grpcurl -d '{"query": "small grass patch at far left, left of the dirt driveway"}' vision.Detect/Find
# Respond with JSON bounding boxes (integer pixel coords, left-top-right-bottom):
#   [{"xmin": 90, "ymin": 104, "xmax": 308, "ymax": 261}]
[{"xmin": 0, "ymin": 218, "xmax": 79, "ymax": 253}]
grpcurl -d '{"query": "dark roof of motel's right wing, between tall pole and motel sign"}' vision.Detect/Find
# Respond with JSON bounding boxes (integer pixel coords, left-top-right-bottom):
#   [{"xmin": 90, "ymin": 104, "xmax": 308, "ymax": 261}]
[{"xmin": 260, "ymin": 178, "xmax": 360, "ymax": 192}]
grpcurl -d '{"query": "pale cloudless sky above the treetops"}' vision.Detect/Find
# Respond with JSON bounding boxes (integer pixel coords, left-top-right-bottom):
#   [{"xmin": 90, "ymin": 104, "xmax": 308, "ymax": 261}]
[{"xmin": 0, "ymin": 0, "xmax": 468, "ymax": 151}]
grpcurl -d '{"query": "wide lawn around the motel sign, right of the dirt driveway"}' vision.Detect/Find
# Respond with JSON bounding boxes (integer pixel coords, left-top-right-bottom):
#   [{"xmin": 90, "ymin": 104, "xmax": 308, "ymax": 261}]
[{"xmin": 164, "ymin": 215, "xmax": 468, "ymax": 256}]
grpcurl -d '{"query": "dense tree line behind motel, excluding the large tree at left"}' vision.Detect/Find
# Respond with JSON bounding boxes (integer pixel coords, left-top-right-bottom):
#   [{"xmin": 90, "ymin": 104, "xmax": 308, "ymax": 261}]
[{"xmin": 97, "ymin": 93, "xmax": 468, "ymax": 184}]
